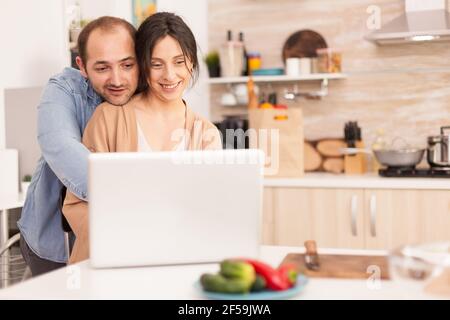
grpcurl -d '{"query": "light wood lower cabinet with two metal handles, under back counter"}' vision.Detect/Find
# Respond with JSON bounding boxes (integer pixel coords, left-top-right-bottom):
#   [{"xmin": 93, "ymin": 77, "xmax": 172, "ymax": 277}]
[{"xmin": 263, "ymin": 187, "xmax": 450, "ymax": 249}]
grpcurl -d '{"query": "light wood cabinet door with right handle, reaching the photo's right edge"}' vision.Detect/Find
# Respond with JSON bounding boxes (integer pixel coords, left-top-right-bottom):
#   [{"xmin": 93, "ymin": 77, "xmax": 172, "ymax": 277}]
[{"xmin": 364, "ymin": 190, "xmax": 450, "ymax": 249}]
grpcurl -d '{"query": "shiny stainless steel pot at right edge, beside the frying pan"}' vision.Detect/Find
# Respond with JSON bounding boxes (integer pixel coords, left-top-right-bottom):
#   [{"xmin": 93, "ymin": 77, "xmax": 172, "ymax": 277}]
[{"xmin": 427, "ymin": 126, "xmax": 450, "ymax": 169}]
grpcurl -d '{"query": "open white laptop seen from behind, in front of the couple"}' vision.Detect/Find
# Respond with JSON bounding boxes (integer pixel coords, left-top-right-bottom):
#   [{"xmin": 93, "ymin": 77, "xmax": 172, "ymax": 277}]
[{"xmin": 88, "ymin": 150, "xmax": 264, "ymax": 268}]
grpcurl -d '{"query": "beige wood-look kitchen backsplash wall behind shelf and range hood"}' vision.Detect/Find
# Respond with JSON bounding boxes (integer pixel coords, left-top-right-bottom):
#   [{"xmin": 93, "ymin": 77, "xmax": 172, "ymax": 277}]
[{"xmin": 208, "ymin": 0, "xmax": 450, "ymax": 146}]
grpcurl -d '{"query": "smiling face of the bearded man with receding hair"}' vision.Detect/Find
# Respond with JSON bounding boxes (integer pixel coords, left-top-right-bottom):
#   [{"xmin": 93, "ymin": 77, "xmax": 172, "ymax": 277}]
[{"xmin": 77, "ymin": 27, "xmax": 139, "ymax": 106}]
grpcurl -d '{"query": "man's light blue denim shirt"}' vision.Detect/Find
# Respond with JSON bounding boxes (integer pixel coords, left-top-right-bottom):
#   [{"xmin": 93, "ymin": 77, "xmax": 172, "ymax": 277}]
[{"xmin": 17, "ymin": 68, "xmax": 102, "ymax": 263}]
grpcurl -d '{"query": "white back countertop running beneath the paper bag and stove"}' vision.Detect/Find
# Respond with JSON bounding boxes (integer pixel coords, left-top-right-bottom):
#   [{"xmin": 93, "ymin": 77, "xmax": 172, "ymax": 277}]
[{"xmin": 264, "ymin": 173, "xmax": 450, "ymax": 190}]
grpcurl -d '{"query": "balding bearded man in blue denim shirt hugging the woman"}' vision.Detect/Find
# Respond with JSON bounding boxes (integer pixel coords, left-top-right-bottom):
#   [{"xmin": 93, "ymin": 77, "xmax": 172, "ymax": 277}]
[{"xmin": 18, "ymin": 17, "xmax": 138, "ymax": 276}]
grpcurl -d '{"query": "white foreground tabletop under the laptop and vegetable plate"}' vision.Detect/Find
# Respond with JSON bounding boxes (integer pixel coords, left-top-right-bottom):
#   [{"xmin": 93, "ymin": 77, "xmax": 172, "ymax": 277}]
[{"xmin": 0, "ymin": 246, "xmax": 440, "ymax": 300}]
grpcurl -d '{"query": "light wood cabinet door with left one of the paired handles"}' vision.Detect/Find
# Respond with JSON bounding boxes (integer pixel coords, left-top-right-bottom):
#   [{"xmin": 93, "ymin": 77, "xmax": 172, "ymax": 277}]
[{"xmin": 272, "ymin": 188, "xmax": 364, "ymax": 248}]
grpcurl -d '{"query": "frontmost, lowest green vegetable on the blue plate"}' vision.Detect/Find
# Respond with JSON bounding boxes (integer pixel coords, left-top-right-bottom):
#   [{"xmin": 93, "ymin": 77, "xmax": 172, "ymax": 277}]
[{"xmin": 200, "ymin": 273, "xmax": 251, "ymax": 293}]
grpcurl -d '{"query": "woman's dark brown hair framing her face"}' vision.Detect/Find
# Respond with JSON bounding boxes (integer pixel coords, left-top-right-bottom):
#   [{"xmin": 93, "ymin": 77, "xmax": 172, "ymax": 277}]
[{"xmin": 135, "ymin": 12, "xmax": 199, "ymax": 92}]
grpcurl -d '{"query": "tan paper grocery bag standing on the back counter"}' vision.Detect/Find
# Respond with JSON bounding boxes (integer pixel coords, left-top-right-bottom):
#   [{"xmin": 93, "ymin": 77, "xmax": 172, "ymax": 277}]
[{"xmin": 248, "ymin": 108, "xmax": 304, "ymax": 177}]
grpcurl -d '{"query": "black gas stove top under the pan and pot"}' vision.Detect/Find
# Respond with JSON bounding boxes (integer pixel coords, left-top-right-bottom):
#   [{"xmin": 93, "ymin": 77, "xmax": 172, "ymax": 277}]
[{"xmin": 378, "ymin": 167, "xmax": 450, "ymax": 178}]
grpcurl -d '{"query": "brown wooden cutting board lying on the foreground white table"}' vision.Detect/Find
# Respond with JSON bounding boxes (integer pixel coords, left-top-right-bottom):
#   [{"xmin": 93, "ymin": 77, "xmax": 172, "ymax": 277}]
[{"xmin": 280, "ymin": 253, "xmax": 389, "ymax": 280}]
